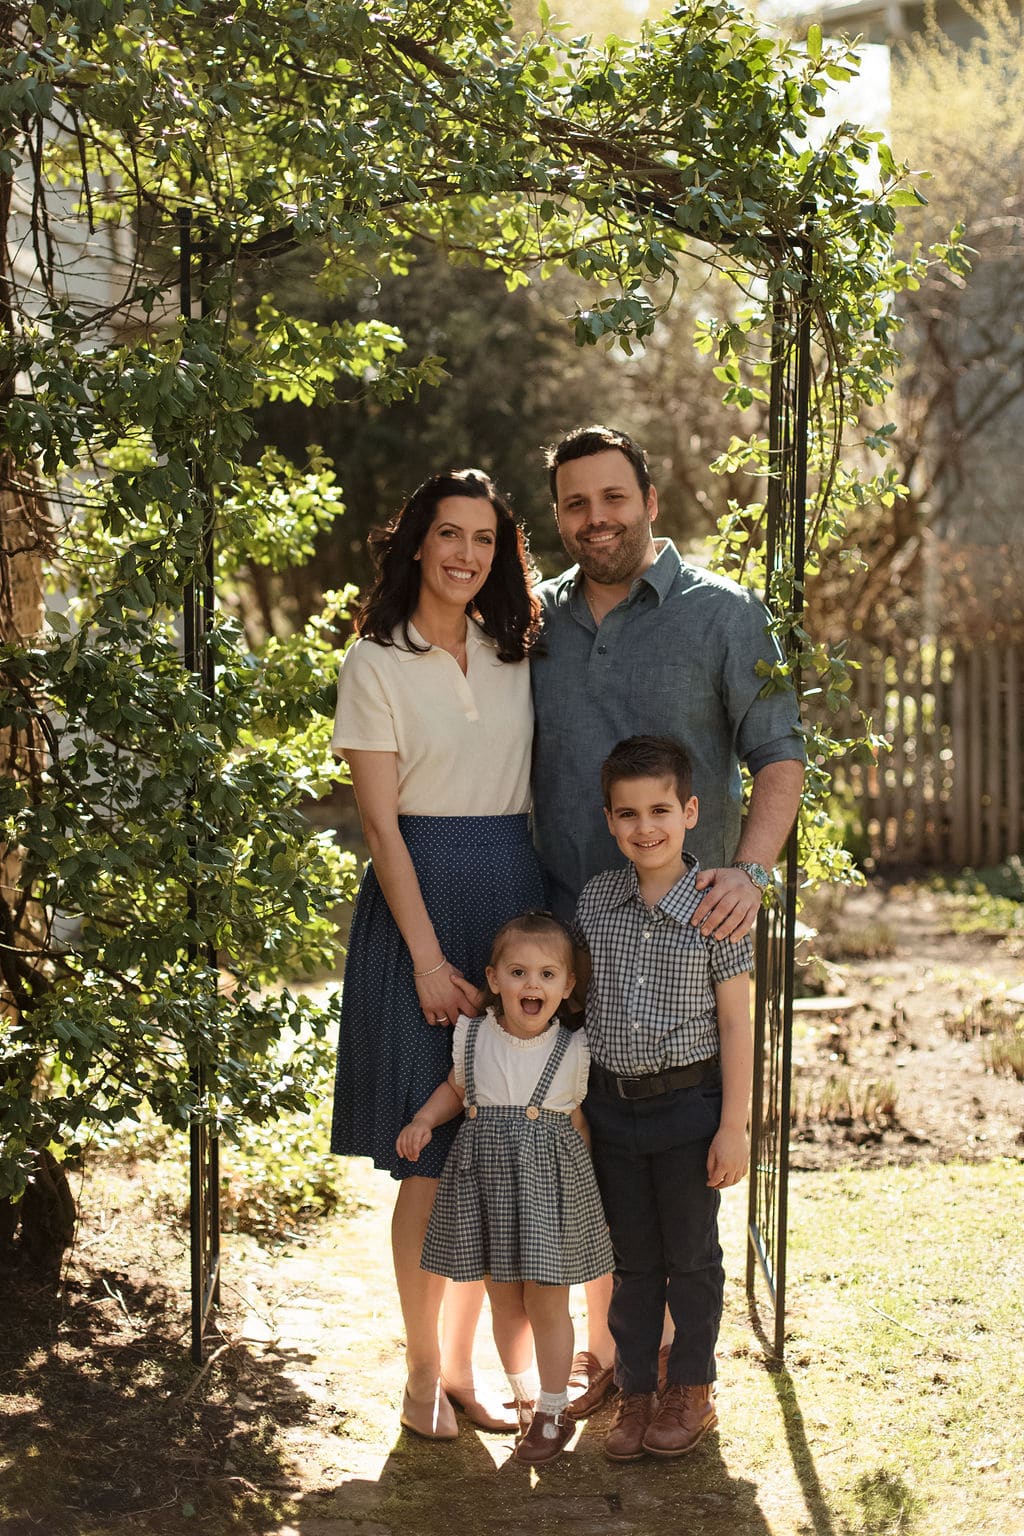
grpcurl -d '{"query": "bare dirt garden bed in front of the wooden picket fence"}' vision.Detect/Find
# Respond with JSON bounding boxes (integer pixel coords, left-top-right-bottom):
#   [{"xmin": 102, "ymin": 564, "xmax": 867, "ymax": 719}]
[{"xmin": 791, "ymin": 886, "xmax": 1024, "ymax": 1169}]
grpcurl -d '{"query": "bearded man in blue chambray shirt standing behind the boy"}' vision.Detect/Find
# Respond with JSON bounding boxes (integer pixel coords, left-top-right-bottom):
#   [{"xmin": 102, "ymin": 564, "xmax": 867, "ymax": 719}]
[{"xmin": 531, "ymin": 427, "xmax": 804, "ymax": 938}]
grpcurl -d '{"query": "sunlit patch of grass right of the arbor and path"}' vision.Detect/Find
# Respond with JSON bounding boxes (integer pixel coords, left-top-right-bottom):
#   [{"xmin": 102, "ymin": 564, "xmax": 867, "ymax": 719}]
[{"xmin": 729, "ymin": 1161, "xmax": 1024, "ymax": 1536}]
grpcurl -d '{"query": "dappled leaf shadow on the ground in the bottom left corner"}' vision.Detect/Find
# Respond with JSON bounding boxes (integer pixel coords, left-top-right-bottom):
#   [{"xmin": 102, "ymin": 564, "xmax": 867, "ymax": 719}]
[{"xmin": 0, "ymin": 1270, "xmax": 307, "ymax": 1536}]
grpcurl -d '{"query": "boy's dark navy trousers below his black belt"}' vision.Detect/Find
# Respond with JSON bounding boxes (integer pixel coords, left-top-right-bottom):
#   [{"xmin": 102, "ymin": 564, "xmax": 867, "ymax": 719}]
[{"xmin": 583, "ymin": 1069, "xmax": 725, "ymax": 1392}]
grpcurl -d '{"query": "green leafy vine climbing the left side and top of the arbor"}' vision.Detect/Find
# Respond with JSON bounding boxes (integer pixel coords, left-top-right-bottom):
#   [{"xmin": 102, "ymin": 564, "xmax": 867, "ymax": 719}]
[{"xmin": 0, "ymin": 0, "xmax": 917, "ymax": 1192}]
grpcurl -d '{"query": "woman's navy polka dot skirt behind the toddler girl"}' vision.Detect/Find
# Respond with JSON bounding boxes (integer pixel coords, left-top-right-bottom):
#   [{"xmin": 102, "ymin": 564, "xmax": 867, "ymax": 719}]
[{"xmin": 330, "ymin": 816, "xmax": 543, "ymax": 1178}]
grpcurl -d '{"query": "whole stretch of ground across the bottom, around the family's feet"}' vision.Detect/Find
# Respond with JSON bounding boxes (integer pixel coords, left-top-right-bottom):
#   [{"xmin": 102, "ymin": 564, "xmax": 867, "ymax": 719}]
[{"xmin": 8, "ymin": 1163, "xmax": 1024, "ymax": 1536}]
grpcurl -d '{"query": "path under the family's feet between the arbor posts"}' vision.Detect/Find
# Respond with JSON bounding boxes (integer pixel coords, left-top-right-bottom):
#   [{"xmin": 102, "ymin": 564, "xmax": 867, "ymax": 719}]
[{"xmin": 224, "ymin": 1163, "xmax": 808, "ymax": 1536}]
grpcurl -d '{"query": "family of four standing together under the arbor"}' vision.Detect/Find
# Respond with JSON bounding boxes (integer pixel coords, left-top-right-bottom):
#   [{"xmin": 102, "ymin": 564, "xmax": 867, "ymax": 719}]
[{"xmin": 332, "ymin": 427, "xmax": 804, "ymax": 1467}]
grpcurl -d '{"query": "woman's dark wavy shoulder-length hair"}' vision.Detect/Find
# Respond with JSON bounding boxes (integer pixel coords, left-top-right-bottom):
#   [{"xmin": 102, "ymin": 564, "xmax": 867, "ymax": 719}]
[{"xmin": 356, "ymin": 470, "xmax": 540, "ymax": 662}]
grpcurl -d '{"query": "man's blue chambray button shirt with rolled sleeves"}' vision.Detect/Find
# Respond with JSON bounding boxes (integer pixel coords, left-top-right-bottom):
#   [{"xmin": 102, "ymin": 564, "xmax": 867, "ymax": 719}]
[{"xmin": 530, "ymin": 541, "xmax": 806, "ymax": 922}]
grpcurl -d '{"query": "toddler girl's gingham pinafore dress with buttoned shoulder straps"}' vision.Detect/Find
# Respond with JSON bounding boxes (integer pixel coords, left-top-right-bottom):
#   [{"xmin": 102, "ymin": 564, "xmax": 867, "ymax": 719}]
[{"xmin": 421, "ymin": 1018, "xmax": 613, "ymax": 1286}]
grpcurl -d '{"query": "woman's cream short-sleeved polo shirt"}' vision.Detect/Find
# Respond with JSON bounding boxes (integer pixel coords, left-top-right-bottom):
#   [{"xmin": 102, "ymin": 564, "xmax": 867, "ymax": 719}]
[{"xmin": 332, "ymin": 619, "xmax": 533, "ymax": 816}]
